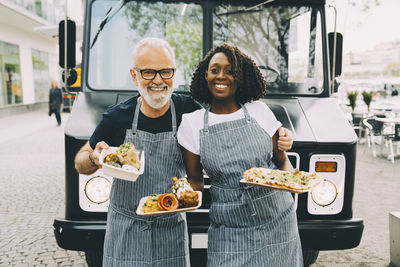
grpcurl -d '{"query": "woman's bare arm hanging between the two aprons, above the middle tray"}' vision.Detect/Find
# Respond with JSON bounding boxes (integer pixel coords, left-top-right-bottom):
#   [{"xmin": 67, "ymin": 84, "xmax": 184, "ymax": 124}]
[{"xmin": 180, "ymin": 146, "xmax": 204, "ymax": 191}]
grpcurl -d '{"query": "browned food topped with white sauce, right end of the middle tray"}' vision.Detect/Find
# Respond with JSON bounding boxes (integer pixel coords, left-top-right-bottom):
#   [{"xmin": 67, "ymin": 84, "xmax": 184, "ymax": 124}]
[{"xmin": 171, "ymin": 177, "xmax": 199, "ymax": 208}]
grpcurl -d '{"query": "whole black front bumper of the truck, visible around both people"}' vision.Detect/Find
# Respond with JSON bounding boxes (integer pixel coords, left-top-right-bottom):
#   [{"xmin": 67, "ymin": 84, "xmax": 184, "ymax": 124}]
[{"xmin": 53, "ymin": 219, "xmax": 364, "ymax": 254}]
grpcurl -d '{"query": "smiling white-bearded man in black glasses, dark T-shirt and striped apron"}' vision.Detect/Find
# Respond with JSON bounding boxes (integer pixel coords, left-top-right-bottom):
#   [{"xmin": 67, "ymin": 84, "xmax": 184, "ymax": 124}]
[{"xmin": 75, "ymin": 38, "xmax": 292, "ymax": 266}]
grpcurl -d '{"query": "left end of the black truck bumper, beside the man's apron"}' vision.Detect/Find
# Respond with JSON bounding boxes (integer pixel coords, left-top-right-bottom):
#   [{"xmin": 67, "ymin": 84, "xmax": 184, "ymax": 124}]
[{"xmin": 53, "ymin": 219, "xmax": 106, "ymax": 251}]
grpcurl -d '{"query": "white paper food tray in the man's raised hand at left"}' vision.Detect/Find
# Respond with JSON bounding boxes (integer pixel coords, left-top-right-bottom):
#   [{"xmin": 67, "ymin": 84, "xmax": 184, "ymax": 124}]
[{"xmin": 100, "ymin": 147, "xmax": 145, "ymax": 182}]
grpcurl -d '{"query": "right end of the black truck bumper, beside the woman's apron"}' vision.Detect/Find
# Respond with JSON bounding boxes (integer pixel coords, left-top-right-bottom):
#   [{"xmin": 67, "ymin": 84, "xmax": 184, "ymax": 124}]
[{"xmin": 298, "ymin": 218, "xmax": 364, "ymax": 250}]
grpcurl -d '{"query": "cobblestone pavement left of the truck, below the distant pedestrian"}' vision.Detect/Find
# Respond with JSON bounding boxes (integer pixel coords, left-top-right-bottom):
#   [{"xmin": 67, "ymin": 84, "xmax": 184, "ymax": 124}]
[{"xmin": 0, "ymin": 110, "xmax": 86, "ymax": 267}]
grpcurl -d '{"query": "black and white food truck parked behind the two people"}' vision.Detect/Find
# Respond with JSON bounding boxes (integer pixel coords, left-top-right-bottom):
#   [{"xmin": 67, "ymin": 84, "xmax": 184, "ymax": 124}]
[{"xmin": 54, "ymin": 0, "xmax": 364, "ymax": 266}]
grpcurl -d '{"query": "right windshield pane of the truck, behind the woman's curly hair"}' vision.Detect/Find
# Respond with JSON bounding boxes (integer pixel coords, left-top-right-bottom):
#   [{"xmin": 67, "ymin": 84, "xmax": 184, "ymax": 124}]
[{"xmin": 213, "ymin": 4, "xmax": 324, "ymax": 95}]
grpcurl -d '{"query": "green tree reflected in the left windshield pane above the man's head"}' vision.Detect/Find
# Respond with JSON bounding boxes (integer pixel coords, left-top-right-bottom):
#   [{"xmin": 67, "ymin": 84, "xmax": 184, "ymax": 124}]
[{"xmin": 124, "ymin": 2, "xmax": 203, "ymax": 81}]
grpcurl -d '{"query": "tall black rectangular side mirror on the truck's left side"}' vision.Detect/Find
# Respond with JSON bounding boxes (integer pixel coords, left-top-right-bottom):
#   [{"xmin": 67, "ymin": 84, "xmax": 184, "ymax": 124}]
[{"xmin": 58, "ymin": 19, "xmax": 76, "ymax": 69}]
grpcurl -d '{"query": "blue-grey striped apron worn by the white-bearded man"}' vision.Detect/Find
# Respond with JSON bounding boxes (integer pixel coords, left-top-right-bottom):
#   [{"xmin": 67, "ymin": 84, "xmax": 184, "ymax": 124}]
[{"xmin": 103, "ymin": 100, "xmax": 190, "ymax": 267}]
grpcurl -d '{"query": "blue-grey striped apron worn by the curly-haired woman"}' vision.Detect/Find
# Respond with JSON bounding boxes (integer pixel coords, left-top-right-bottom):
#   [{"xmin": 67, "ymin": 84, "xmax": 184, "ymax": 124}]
[{"xmin": 200, "ymin": 106, "xmax": 303, "ymax": 267}]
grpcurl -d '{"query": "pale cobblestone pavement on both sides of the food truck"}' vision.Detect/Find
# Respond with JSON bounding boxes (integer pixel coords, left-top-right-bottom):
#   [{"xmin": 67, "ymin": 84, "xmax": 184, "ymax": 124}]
[{"xmin": 0, "ymin": 105, "xmax": 400, "ymax": 267}]
